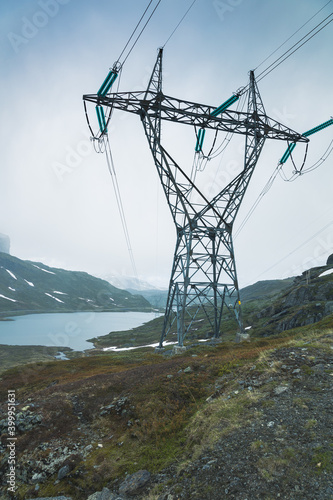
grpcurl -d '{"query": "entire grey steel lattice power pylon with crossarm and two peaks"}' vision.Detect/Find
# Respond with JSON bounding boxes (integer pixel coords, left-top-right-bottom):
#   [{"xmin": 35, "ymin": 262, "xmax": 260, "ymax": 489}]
[{"xmin": 83, "ymin": 49, "xmax": 308, "ymax": 347}]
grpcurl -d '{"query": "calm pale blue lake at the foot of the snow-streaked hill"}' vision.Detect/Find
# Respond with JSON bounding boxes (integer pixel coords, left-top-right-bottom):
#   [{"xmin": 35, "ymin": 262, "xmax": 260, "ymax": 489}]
[{"xmin": 0, "ymin": 312, "xmax": 157, "ymax": 351}]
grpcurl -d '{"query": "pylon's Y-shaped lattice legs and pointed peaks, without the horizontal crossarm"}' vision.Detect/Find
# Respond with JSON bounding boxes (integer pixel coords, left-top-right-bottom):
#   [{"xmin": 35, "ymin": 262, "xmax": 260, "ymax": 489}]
[{"xmin": 141, "ymin": 52, "xmax": 265, "ymax": 347}]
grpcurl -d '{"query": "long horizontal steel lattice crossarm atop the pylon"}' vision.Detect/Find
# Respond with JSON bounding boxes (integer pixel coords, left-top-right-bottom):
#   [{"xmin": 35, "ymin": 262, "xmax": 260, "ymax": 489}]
[{"xmin": 83, "ymin": 91, "xmax": 309, "ymax": 142}]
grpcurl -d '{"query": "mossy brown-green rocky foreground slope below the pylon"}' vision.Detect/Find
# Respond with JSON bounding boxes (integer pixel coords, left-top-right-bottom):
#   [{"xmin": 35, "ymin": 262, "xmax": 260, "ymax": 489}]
[{"xmin": 0, "ymin": 322, "xmax": 333, "ymax": 500}]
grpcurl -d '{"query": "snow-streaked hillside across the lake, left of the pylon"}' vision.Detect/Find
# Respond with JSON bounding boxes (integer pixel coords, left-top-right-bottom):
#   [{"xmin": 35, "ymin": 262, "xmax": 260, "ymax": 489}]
[{"xmin": 0, "ymin": 252, "xmax": 151, "ymax": 317}]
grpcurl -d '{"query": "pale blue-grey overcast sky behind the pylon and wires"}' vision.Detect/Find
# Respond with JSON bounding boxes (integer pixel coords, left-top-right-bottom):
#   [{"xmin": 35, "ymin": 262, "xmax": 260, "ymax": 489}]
[{"xmin": 0, "ymin": 0, "xmax": 333, "ymax": 286}]
